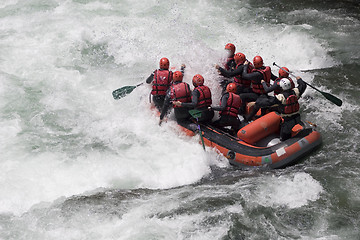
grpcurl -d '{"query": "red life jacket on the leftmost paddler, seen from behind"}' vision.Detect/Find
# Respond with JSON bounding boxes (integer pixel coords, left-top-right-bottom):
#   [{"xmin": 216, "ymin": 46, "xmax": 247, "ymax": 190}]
[{"xmin": 151, "ymin": 69, "xmax": 172, "ymax": 96}]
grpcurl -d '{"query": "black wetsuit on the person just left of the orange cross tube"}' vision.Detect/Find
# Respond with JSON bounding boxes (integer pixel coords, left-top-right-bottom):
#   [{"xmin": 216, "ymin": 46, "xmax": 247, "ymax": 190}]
[{"xmin": 211, "ymin": 92, "xmax": 240, "ymax": 132}]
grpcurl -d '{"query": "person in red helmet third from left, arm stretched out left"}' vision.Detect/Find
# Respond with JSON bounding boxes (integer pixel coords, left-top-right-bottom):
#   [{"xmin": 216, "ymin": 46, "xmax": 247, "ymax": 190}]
[{"xmin": 174, "ymin": 74, "xmax": 214, "ymax": 122}]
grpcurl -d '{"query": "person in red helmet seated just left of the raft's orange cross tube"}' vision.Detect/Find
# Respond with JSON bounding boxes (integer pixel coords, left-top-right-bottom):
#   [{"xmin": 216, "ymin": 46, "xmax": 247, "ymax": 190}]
[{"xmin": 210, "ymin": 83, "xmax": 241, "ymax": 135}]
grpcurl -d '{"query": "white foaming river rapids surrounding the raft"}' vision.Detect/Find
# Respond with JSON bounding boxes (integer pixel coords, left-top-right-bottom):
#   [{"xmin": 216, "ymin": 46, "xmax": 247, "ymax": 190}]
[{"xmin": 0, "ymin": 0, "xmax": 360, "ymax": 240}]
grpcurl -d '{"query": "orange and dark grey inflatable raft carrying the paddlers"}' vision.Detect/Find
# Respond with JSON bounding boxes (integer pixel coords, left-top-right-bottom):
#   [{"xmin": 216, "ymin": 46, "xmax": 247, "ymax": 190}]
[{"xmin": 182, "ymin": 112, "xmax": 322, "ymax": 168}]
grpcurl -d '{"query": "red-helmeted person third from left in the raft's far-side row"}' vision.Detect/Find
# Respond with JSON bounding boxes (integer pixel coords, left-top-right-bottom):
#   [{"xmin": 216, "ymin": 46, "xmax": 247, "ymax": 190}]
[{"xmin": 240, "ymin": 56, "xmax": 277, "ymax": 113}]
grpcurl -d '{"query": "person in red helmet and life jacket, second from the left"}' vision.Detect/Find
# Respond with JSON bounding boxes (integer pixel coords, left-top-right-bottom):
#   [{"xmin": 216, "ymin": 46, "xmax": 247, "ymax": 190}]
[{"xmin": 159, "ymin": 65, "xmax": 191, "ymax": 125}]
